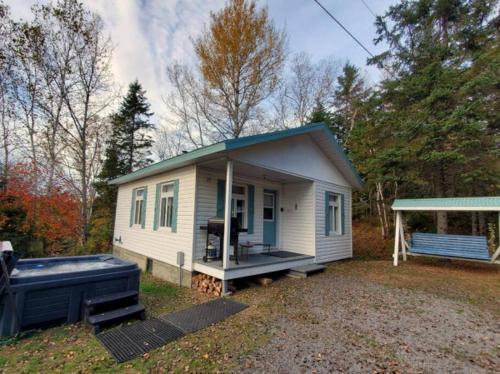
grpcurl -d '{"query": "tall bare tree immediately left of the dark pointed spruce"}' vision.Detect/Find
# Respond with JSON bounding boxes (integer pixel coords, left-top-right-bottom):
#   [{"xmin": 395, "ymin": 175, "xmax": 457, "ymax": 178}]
[{"xmin": 52, "ymin": 1, "xmax": 114, "ymax": 242}]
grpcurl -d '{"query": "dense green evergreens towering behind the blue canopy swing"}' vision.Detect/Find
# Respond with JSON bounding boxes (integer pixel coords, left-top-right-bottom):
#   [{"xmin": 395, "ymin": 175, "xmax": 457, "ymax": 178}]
[{"xmin": 350, "ymin": 0, "xmax": 500, "ymax": 232}]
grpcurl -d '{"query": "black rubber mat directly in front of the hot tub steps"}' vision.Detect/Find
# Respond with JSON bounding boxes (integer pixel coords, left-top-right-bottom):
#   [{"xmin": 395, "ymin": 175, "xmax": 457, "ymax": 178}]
[{"xmin": 96, "ymin": 319, "xmax": 184, "ymax": 362}]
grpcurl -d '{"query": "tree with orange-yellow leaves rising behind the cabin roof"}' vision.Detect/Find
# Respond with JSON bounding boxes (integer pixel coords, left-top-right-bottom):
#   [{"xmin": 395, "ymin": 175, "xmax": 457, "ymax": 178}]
[{"xmin": 194, "ymin": 0, "xmax": 286, "ymax": 138}]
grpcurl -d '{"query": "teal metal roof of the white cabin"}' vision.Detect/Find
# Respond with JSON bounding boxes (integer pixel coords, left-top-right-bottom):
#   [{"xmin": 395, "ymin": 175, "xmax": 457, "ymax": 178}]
[{"xmin": 109, "ymin": 122, "xmax": 363, "ymax": 187}]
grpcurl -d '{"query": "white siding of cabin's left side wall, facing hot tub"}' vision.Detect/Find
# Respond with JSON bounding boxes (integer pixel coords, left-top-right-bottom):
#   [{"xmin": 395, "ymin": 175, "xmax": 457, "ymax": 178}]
[{"xmin": 114, "ymin": 166, "xmax": 196, "ymax": 270}]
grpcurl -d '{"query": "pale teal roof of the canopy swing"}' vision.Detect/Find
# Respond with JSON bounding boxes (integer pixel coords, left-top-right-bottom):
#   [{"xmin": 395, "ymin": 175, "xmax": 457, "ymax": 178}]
[{"xmin": 392, "ymin": 196, "xmax": 500, "ymax": 211}]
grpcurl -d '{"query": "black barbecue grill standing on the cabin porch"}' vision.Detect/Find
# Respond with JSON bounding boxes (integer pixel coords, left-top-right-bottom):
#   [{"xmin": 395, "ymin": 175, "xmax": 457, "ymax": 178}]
[{"xmin": 200, "ymin": 217, "xmax": 248, "ymax": 264}]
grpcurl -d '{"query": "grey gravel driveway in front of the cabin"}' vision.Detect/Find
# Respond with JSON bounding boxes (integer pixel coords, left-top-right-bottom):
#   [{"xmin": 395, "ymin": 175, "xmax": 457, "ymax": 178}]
[{"xmin": 240, "ymin": 271, "xmax": 500, "ymax": 373}]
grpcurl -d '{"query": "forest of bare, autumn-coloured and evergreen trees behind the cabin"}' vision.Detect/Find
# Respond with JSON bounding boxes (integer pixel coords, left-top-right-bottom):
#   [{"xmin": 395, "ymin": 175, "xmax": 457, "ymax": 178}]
[{"xmin": 0, "ymin": 0, "xmax": 500, "ymax": 256}]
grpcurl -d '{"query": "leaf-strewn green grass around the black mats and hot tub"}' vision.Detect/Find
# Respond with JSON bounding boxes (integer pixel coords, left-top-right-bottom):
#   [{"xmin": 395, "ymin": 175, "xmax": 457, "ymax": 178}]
[{"xmin": 0, "ymin": 274, "xmax": 275, "ymax": 374}]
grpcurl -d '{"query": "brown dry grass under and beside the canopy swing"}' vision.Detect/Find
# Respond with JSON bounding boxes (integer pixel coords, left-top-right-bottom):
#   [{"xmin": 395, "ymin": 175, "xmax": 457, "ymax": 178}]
[{"xmin": 352, "ymin": 221, "xmax": 500, "ymax": 314}]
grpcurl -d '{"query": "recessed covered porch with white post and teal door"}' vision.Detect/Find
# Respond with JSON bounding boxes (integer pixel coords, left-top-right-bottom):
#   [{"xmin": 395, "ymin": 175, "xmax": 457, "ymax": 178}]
[{"xmin": 193, "ymin": 158, "xmax": 315, "ymax": 281}]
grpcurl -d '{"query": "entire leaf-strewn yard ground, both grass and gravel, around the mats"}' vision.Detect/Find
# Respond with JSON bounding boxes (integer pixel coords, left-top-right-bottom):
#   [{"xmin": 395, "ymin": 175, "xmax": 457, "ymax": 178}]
[{"xmin": 0, "ymin": 259, "xmax": 500, "ymax": 373}]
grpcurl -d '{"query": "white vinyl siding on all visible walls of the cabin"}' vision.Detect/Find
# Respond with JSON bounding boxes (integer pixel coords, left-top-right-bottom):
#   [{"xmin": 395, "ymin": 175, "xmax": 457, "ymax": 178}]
[{"xmin": 114, "ymin": 137, "xmax": 352, "ymax": 270}]
